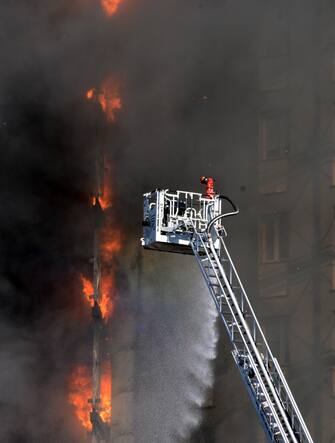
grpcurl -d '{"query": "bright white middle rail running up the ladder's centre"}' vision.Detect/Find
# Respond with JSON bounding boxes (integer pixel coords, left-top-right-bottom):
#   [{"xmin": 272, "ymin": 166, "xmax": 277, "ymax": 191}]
[{"xmin": 209, "ymin": 239, "xmax": 298, "ymax": 443}]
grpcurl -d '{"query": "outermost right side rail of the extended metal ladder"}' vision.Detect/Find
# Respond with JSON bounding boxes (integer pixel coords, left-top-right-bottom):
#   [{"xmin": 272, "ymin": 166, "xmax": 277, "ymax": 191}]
[{"xmin": 220, "ymin": 231, "xmax": 313, "ymax": 443}]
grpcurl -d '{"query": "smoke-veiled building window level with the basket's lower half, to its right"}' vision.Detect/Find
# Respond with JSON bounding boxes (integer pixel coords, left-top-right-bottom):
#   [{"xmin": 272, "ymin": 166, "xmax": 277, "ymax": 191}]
[{"xmin": 259, "ymin": 214, "xmax": 288, "ymax": 262}]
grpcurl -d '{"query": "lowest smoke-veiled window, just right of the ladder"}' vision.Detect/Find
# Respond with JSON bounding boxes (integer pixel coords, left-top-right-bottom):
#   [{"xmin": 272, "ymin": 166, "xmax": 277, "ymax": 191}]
[{"xmin": 263, "ymin": 317, "xmax": 290, "ymax": 364}]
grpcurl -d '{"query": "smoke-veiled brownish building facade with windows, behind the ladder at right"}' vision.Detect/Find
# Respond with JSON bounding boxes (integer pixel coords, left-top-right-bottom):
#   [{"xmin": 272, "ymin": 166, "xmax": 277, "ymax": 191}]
[{"xmin": 197, "ymin": 1, "xmax": 335, "ymax": 443}]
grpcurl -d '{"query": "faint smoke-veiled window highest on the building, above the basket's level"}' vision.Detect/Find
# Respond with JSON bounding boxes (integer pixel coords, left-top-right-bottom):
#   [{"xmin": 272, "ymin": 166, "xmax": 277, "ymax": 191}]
[{"xmin": 260, "ymin": 112, "xmax": 288, "ymax": 160}]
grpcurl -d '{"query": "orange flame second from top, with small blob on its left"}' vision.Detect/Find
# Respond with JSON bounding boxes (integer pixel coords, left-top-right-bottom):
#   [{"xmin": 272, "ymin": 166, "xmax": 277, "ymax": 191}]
[{"xmin": 86, "ymin": 77, "xmax": 122, "ymax": 123}]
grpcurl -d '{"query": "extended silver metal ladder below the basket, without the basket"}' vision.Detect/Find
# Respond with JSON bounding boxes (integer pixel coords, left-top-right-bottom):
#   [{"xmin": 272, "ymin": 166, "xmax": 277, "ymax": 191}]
[{"xmin": 190, "ymin": 221, "xmax": 313, "ymax": 443}]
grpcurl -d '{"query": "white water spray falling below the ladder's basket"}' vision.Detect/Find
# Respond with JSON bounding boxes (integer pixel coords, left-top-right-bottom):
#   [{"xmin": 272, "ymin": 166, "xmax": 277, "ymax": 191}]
[{"xmin": 135, "ymin": 252, "xmax": 217, "ymax": 443}]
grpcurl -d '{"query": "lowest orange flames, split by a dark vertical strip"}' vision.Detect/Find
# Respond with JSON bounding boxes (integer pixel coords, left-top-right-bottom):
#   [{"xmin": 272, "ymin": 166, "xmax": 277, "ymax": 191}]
[{"xmin": 68, "ymin": 362, "xmax": 112, "ymax": 431}]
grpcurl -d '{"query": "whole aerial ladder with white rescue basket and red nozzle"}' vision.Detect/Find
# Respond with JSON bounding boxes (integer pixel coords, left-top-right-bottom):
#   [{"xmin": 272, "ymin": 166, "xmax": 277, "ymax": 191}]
[{"xmin": 141, "ymin": 177, "xmax": 313, "ymax": 443}]
